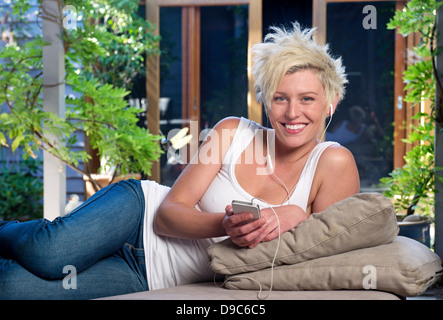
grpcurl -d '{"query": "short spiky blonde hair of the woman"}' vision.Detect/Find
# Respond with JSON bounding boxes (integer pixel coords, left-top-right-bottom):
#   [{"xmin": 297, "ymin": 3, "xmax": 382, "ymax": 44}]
[{"xmin": 251, "ymin": 22, "xmax": 348, "ymax": 111}]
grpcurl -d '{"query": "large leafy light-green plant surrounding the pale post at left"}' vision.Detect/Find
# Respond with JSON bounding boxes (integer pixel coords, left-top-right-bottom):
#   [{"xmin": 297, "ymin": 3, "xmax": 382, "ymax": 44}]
[{"xmin": 0, "ymin": 0, "xmax": 161, "ymax": 190}]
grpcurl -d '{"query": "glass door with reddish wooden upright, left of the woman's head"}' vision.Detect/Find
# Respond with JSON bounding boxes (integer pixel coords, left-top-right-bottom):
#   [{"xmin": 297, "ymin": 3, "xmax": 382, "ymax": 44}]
[{"xmin": 152, "ymin": 0, "xmax": 261, "ymax": 185}]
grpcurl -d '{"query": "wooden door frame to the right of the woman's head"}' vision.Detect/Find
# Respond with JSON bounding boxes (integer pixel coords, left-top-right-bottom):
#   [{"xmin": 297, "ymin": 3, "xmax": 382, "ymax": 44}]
[{"xmin": 312, "ymin": 0, "xmax": 411, "ymax": 168}]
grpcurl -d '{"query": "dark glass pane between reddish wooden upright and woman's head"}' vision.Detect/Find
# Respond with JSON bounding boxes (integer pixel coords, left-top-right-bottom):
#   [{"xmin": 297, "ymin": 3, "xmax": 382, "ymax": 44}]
[{"xmin": 200, "ymin": 5, "xmax": 248, "ymax": 130}]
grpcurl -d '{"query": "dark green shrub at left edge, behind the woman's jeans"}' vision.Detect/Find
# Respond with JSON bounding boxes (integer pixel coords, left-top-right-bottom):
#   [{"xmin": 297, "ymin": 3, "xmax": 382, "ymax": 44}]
[{"xmin": 0, "ymin": 159, "xmax": 43, "ymax": 220}]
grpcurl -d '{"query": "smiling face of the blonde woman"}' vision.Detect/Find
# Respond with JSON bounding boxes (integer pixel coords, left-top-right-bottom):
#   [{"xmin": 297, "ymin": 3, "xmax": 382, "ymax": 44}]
[{"xmin": 268, "ymin": 69, "xmax": 327, "ymax": 152}]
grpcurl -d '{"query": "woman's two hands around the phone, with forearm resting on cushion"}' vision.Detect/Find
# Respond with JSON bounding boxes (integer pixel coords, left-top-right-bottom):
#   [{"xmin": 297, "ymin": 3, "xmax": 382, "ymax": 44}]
[{"xmin": 222, "ymin": 205, "xmax": 307, "ymax": 248}]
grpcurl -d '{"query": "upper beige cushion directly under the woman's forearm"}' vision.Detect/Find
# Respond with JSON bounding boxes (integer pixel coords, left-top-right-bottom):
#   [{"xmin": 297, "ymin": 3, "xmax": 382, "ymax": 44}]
[{"xmin": 208, "ymin": 193, "xmax": 398, "ymax": 274}]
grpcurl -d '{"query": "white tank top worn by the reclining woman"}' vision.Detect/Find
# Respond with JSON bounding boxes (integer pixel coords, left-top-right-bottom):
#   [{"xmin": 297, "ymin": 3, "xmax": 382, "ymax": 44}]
[{"xmin": 142, "ymin": 118, "xmax": 334, "ymax": 290}]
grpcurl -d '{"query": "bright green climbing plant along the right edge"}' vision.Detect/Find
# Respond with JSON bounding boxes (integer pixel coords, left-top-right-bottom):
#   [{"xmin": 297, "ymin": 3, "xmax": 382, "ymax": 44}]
[{"xmin": 381, "ymin": 0, "xmax": 441, "ymax": 217}]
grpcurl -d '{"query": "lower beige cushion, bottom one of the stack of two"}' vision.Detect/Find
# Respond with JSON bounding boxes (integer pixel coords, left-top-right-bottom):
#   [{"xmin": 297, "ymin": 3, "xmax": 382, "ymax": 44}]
[{"xmin": 225, "ymin": 236, "xmax": 442, "ymax": 297}]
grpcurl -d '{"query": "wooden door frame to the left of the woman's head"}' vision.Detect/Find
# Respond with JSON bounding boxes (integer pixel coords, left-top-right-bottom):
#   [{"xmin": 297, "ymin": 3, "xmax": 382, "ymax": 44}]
[{"xmin": 145, "ymin": 0, "xmax": 263, "ymax": 181}]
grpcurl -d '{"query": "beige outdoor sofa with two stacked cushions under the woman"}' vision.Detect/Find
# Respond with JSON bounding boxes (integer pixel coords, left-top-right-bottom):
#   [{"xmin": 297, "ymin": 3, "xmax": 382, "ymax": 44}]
[{"xmin": 101, "ymin": 193, "xmax": 442, "ymax": 300}]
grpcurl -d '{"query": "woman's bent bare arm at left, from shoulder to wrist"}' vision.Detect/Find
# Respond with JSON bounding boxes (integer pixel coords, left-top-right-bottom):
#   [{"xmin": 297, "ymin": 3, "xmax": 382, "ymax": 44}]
[{"xmin": 154, "ymin": 118, "xmax": 251, "ymax": 238}]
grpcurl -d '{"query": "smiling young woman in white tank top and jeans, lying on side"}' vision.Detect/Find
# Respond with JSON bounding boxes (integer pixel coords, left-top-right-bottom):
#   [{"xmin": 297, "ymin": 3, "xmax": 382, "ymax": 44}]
[{"xmin": 0, "ymin": 23, "xmax": 359, "ymax": 299}]
